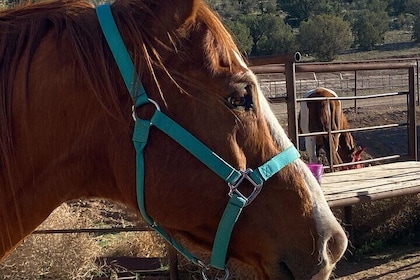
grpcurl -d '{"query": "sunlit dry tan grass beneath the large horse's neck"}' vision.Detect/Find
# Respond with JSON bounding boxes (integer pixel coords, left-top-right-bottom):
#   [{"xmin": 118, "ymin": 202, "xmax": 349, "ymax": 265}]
[{"xmin": 0, "ymin": 202, "xmax": 166, "ymax": 280}]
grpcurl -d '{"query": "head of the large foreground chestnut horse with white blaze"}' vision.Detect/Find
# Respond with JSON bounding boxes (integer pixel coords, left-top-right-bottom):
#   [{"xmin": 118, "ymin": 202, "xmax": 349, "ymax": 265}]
[{"xmin": 124, "ymin": 1, "xmax": 346, "ymax": 279}]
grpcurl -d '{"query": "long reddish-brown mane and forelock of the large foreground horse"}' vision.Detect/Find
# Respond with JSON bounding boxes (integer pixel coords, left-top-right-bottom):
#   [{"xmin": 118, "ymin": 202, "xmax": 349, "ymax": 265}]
[{"xmin": 0, "ymin": 0, "xmax": 240, "ymax": 184}]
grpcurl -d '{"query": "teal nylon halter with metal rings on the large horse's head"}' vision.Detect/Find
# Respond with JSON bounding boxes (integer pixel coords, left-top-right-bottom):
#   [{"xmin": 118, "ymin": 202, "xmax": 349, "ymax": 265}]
[{"xmin": 96, "ymin": 4, "xmax": 299, "ymax": 279}]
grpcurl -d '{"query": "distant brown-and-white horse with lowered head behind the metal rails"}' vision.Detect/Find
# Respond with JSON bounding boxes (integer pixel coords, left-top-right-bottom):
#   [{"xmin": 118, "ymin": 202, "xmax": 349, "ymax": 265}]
[{"xmin": 299, "ymin": 87, "xmax": 365, "ymax": 169}]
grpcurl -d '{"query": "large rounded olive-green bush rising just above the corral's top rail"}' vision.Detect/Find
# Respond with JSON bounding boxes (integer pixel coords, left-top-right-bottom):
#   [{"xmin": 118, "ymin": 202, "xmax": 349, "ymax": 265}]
[{"xmin": 297, "ymin": 14, "xmax": 353, "ymax": 61}]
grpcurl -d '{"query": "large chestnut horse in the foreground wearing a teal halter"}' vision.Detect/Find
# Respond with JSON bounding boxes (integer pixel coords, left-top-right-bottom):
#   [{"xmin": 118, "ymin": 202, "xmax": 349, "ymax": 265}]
[{"xmin": 0, "ymin": 0, "xmax": 347, "ymax": 279}]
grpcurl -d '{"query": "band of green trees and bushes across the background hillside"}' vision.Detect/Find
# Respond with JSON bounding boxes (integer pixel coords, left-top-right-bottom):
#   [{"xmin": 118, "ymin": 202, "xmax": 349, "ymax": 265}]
[{"xmin": 207, "ymin": 0, "xmax": 420, "ymax": 57}]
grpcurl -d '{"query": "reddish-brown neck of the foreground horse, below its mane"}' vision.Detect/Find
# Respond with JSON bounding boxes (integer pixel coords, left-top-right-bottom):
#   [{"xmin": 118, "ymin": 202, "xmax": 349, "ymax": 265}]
[{"xmin": 0, "ymin": 56, "xmax": 136, "ymax": 259}]
